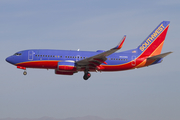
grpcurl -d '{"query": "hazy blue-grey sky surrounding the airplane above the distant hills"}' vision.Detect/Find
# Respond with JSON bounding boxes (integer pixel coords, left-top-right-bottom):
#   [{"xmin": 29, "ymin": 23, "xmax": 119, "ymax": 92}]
[{"xmin": 0, "ymin": 0, "xmax": 180, "ymax": 120}]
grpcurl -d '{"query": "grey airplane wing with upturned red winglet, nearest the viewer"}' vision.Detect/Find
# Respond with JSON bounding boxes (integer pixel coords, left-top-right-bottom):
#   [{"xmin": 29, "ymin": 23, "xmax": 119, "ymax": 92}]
[{"xmin": 76, "ymin": 35, "xmax": 126, "ymax": 69}]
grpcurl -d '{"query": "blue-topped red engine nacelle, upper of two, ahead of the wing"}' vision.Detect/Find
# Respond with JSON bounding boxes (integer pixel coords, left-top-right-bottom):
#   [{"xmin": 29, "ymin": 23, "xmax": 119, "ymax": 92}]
[{"xmin": 57, "ymin": 61, "xmax": 76, "ymax": 72}]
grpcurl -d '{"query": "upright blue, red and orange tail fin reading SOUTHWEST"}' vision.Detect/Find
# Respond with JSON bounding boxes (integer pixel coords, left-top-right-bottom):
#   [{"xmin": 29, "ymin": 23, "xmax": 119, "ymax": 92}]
[{"xmin": 137, "ymin": 21, "xmax": 170, "ymax": 56}]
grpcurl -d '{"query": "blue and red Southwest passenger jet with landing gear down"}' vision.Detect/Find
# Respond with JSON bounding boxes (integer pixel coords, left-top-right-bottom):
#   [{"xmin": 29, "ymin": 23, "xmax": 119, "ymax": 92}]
[{"xmin": 6, "ymin": 21, "xmax": 172, "ymax": 80}]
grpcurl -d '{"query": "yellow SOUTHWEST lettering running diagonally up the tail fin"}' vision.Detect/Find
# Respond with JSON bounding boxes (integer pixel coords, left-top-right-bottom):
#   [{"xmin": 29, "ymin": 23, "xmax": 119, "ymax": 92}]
[{"xmin": 139, "ymin": 24, "xmax": 165, "ymax": 51}]
